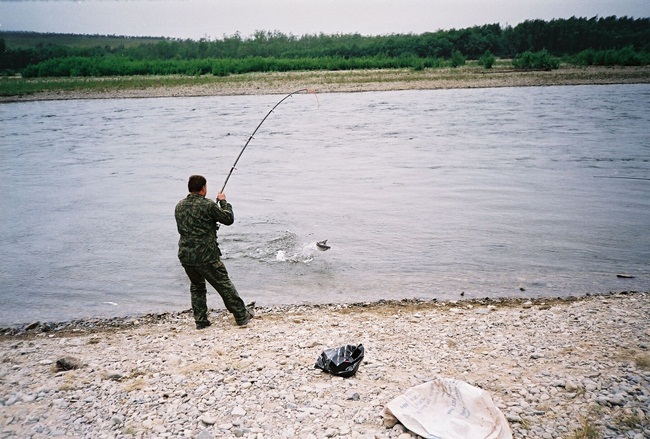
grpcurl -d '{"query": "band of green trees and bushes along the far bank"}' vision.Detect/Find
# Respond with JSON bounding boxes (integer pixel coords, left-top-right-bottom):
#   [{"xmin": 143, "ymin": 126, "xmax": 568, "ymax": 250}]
[{"xmin": 0, "ymin": 16, "xmax": 650, "ymax": 78}]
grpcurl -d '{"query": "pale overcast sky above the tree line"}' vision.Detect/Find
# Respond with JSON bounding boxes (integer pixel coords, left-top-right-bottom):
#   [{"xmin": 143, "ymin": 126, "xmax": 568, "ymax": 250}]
[{"xmin": 0, "ymin": 0, "xmax": 650, "ymax": 39}]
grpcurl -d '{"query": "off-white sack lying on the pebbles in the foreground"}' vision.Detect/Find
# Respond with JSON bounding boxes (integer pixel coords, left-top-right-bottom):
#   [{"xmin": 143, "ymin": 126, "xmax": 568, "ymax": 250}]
[{"xmin": 382, "ymin": 377, "xmax": 512, "ymax": 439}]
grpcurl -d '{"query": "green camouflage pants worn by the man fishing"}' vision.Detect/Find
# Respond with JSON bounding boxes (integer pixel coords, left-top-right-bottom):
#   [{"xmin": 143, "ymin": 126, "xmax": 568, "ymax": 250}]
[{"xmin": 183, "ymin": 260, "xmax": 246, "ymax": 323}]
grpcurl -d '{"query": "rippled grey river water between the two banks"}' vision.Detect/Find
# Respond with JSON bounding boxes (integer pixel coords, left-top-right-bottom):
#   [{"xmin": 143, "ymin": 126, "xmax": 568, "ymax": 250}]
[{"xmin": 0, "ymin": 85, "xmax": 650, "ymax": 325}]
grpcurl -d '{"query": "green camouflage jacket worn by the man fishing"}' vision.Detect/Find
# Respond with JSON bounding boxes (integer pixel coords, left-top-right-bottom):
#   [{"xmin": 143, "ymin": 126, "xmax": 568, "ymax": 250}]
[{"xmin": 175, "ymin": 194, "xmax": 235, "ymax": 265}]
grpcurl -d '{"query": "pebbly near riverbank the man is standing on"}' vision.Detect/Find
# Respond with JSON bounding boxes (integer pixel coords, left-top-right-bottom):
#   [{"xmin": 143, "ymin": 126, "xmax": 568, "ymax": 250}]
[{"xmin": 0, "ymin": 292, "xmax": 650, "ymax": 439}]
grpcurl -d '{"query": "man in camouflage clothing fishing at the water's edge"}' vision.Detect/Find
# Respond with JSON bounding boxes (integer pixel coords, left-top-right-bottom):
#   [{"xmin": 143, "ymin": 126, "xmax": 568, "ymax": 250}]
[{"xmin": 175, "ymin": 175, "xmax": 253, "ymax": 329}]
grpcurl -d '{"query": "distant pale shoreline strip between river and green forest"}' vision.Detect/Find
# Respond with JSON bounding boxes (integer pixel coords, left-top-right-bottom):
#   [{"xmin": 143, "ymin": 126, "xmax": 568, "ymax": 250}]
[{"xmin": 0, "ymin": 66, "xmax": 650, "ymax": 103}]
